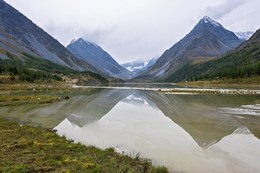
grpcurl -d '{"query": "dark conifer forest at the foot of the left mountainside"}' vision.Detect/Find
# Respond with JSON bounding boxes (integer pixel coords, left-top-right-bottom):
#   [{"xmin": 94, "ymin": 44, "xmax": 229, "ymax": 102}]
[{"xmin": 0, "ymin": 52, "xmax": 107, "ymax": 82}]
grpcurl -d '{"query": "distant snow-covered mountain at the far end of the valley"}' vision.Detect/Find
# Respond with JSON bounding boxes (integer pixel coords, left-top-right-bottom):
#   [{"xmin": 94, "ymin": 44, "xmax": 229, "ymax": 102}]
[{"xmin": 121, "ymin": 57, "xmax": 158, "ymax": 74}]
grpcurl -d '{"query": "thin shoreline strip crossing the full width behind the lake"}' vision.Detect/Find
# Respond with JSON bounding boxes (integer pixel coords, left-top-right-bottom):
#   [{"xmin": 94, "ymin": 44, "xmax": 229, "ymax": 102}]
[{"xmin": 0, "ymin": 83, "xmax": 260, "ymax": 95}]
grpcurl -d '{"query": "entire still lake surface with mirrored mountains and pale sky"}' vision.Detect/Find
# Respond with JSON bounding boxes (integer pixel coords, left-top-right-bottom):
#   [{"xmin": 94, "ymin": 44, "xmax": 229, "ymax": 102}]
[{"xmin": 0, "ymin": 89, "xmax": 260, "ymax": 173}]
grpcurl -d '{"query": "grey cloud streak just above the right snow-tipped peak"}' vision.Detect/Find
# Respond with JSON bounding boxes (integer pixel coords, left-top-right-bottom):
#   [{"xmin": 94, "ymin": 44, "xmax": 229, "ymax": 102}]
[{"xmin": 205, "ymin": 0, "xmax": 247, "ymax": 20}]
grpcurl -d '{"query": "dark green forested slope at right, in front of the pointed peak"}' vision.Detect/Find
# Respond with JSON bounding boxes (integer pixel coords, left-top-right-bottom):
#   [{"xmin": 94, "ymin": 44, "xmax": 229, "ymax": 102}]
[{"xmin": 165, "ymin": 29, "xmax": 260, "ymax": 84}]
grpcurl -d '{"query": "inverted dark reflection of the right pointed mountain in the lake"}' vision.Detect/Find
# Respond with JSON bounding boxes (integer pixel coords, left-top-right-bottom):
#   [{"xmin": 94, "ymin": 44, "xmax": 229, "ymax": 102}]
[{"xmin": 142, "ymin": 92, "xmax": 260, "ymax": 149}]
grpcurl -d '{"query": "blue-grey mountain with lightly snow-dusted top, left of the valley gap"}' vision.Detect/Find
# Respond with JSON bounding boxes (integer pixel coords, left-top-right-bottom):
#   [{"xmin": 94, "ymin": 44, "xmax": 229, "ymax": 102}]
[{"xmin": 67, "ymin": 38, "xmax": 132, "ymax": 79}]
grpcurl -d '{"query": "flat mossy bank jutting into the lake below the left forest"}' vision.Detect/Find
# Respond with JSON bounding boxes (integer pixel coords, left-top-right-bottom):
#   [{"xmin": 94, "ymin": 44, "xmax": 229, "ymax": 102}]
[{"xmin": 0, "ymin": 83, "xmax": 94, "ymax": 106}]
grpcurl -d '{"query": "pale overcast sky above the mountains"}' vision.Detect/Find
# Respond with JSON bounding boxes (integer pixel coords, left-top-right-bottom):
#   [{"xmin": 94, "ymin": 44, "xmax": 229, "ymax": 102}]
[{"xmin": 5, "ymin": 0, "xmax": 260, "ymax": 63}]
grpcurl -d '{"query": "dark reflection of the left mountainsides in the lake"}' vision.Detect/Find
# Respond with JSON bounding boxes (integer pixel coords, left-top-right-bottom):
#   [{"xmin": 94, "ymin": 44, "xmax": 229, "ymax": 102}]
[{"xmin": 0, "ymin": 89, "xmax": 129, "ymax": 129}]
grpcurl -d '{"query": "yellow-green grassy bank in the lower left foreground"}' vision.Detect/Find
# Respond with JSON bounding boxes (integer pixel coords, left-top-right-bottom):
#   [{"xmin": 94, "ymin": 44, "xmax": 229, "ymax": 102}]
[{"xmin": 0, "ymin": 118, "xmax": 168, "ymax": 173}]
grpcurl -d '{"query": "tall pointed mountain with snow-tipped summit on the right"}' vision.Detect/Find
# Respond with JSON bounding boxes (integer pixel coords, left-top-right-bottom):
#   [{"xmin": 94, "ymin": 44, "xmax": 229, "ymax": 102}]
[{"xmin": 135, "ymin": 16, "xmax": 242, "ymax": 81}]
